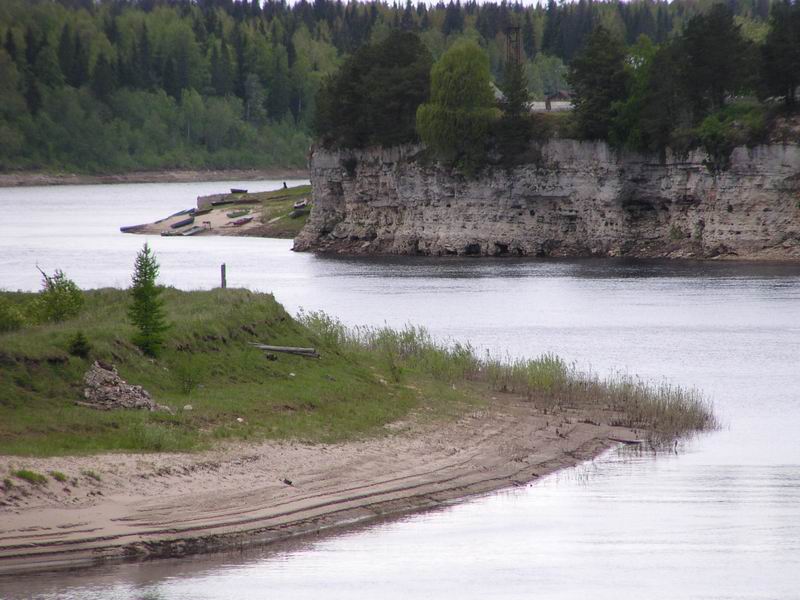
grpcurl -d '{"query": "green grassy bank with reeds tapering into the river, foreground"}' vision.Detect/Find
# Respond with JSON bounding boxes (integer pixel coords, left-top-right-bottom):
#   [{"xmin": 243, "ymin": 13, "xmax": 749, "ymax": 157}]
[{"xmin": 0, "ymin": 289, "xmax": 714, "ymax": 456}]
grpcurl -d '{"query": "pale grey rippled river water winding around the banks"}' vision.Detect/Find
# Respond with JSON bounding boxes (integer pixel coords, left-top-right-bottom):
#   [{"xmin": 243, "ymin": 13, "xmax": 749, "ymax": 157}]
[{"xmin": 0, "ymin": 182, "xmax": 800, "ymax": 600}]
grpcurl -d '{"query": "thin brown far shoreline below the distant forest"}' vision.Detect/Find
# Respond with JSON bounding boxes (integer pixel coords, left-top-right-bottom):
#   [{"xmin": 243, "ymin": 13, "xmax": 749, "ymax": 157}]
[{"xmin": 0, "ymin": 168, "xmax": 308, "ymax": 188}]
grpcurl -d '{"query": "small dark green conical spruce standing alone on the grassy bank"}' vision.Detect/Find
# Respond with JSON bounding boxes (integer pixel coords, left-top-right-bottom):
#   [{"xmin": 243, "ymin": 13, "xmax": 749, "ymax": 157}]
[{"xmin": 128, "ymin": 243, "xmax": 169, "ymax": 356}]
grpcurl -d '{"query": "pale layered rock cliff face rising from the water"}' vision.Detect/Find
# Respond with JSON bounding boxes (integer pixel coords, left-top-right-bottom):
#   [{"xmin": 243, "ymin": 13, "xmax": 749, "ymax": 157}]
[{"xmin": 295, "ymin": 140, "xmax": 800, "ymax": 260}]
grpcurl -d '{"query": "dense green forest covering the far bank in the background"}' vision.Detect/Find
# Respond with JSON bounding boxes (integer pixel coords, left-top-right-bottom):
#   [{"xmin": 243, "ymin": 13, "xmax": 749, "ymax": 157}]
[{"xmin": 0, "ymin": 0, "xmax": 793, "ymax": 172}]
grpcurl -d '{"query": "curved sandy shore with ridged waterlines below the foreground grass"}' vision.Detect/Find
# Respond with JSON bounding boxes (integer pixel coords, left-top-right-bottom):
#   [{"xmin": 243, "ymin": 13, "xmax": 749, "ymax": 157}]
[{"xmin": 0, "ymin": 394, "xmax": 639, "ymax": 576}]
